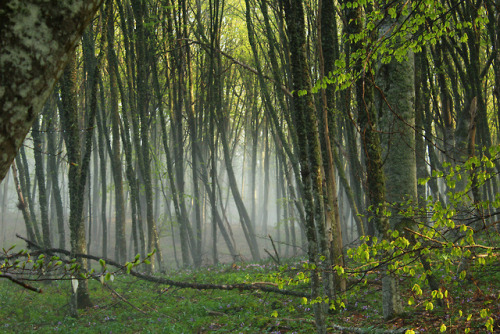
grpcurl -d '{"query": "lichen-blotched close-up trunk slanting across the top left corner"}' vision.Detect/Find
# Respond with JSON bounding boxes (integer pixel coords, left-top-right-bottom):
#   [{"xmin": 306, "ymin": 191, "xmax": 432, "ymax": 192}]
[{"xmin": 0, "ymin": 0, "xmax": 102, "ymax": 180}]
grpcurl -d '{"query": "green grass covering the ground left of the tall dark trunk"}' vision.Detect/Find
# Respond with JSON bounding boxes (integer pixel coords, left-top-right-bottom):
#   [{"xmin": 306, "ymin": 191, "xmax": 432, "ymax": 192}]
[{"xmin": 0, "ymin": 263, "xmax": 314, "ymax": 333}]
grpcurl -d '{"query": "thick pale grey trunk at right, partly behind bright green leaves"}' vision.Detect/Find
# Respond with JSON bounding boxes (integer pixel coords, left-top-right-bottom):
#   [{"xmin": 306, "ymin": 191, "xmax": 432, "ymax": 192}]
[{"xmin": 378, "ymin": 9, "xmax": 417, "ymax": 319}]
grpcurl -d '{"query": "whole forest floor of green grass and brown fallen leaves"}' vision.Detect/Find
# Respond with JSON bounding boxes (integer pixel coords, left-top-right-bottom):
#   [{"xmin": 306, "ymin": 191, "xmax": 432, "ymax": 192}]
[{"xmin": 0, "ymin": 254, "xmax": 500, "ymax": 333}]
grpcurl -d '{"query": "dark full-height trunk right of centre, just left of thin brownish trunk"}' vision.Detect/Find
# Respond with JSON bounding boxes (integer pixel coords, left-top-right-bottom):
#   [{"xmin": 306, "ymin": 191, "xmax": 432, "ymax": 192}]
[{"xmin": 284, "ymin": 0, "xmax": 330, "ymax": 333}]
